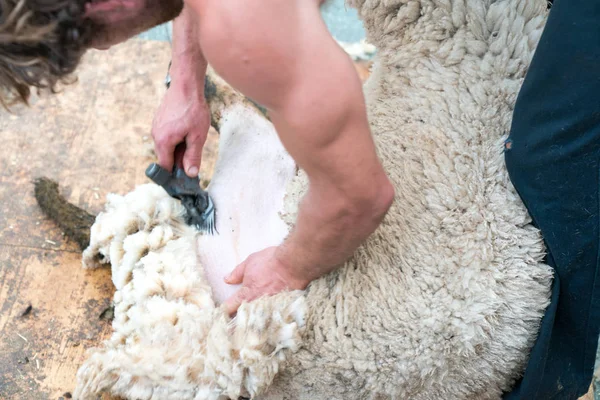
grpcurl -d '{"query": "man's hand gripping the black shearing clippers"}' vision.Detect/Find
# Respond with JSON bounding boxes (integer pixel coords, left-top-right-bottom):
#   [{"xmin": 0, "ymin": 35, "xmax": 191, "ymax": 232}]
[{"xmin": 152, "ymin": 81, "xmax": 210, "ymax": 173}]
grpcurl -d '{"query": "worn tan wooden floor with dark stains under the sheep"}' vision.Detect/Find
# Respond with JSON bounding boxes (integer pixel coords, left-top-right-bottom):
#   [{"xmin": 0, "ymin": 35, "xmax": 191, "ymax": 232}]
[{"xmin": 0, "ymin": 40, "xmax": 592, "ymax": 400}]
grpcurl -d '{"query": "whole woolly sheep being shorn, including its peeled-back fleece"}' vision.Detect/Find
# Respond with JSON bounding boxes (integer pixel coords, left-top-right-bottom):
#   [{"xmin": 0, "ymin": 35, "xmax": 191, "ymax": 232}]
[{"xmin": 75, "ymin": 0, "xmax": 553, "ymax": 400}]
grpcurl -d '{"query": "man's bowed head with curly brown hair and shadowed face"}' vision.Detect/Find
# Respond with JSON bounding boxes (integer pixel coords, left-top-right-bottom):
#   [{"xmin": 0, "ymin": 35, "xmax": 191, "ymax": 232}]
[{"xmin": 0, "ymin": 0, "xmax": 183, "ymax": 105}]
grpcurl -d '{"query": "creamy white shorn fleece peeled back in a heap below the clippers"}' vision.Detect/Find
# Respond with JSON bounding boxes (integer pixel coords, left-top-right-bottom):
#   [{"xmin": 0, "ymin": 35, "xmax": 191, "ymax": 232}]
[{"xmin": 75, "ymin": 184, "xmax": 305, "ymax": 400}]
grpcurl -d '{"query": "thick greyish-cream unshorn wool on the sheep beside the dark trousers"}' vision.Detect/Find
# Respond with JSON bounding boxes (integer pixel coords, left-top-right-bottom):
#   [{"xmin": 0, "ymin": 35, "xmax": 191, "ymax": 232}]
[{"xmin": 267, "ymin": 0, "xmax": 552, "ymax": 400}]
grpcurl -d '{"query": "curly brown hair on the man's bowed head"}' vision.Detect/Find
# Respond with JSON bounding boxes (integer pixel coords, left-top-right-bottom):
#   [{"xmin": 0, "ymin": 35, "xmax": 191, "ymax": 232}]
[{"xmin": 0, "ymin": 0, "xmax": 91, "ymax": 107}]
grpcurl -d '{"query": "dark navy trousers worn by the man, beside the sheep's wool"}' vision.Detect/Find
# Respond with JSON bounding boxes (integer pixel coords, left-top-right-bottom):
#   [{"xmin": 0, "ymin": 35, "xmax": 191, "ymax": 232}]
[{"xmin": 504, "ymin": 0, "xmax": 600, "ymax": 400}]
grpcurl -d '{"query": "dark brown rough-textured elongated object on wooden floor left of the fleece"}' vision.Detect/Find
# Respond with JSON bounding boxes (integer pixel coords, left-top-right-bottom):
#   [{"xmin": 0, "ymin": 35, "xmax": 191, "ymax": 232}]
[{"xmin": 34, "ymin": 178, "xmax": 96, "ymax": 251}]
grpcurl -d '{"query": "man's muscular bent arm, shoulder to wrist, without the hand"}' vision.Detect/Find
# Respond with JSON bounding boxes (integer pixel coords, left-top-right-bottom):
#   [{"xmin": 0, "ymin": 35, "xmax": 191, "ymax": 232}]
[{"xmin": 188, "ymin": 0, "xmax": 394, "ymax": 288}]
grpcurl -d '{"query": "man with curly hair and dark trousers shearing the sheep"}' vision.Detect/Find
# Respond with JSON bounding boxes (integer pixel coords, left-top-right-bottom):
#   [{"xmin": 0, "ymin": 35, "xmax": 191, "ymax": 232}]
[{"xmin": 0, "ymin": 0, "xmax": 600, "ymax": 400}]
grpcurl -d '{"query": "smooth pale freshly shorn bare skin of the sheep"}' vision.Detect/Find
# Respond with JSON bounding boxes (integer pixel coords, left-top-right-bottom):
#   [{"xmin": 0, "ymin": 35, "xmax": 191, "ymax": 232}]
[{"xmin": 198, "ymin": 94, "xmax": 296, "ymax": 302}]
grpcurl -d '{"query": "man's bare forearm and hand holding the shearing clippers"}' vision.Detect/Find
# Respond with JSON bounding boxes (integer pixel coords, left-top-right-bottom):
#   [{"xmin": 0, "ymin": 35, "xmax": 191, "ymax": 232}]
[{"xmin": 152, "ymin": 5, "xmax": 210, "ymax": 176}]
